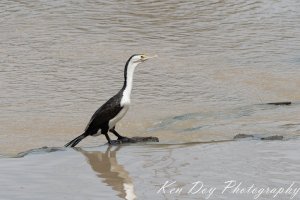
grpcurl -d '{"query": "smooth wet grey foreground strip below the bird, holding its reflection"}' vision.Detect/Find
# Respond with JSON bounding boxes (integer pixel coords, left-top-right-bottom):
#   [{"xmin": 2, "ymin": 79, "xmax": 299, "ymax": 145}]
[{"xmin": 0, "ymin": 139, "xmax": 300, "ymax": 200}]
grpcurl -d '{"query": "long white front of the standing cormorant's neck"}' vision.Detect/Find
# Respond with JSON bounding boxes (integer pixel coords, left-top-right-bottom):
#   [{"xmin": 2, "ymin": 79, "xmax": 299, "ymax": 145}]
[{"xmin": 121, "ymin": 62, "xmax": 138, "ymax": 106}]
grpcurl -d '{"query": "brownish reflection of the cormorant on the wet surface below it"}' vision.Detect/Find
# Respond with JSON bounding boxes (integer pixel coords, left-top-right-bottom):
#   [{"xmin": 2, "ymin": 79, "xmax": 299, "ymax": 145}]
[{"xmin": 76, "ymin": 146, "xmax": 136, "ymax": 200}]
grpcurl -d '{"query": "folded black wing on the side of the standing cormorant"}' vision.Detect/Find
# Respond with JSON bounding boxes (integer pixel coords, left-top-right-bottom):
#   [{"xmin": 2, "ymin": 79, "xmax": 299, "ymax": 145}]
[{"xmin": 85, "ymin": 93, "xmax": 122, "ymax": 134}]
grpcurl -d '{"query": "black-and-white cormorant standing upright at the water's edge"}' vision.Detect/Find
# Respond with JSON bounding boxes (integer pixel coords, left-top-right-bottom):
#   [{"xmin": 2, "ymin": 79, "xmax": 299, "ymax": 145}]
[{"xmin": 65, "ymin": 54, "xmax": 157, "ymax": 147}]
